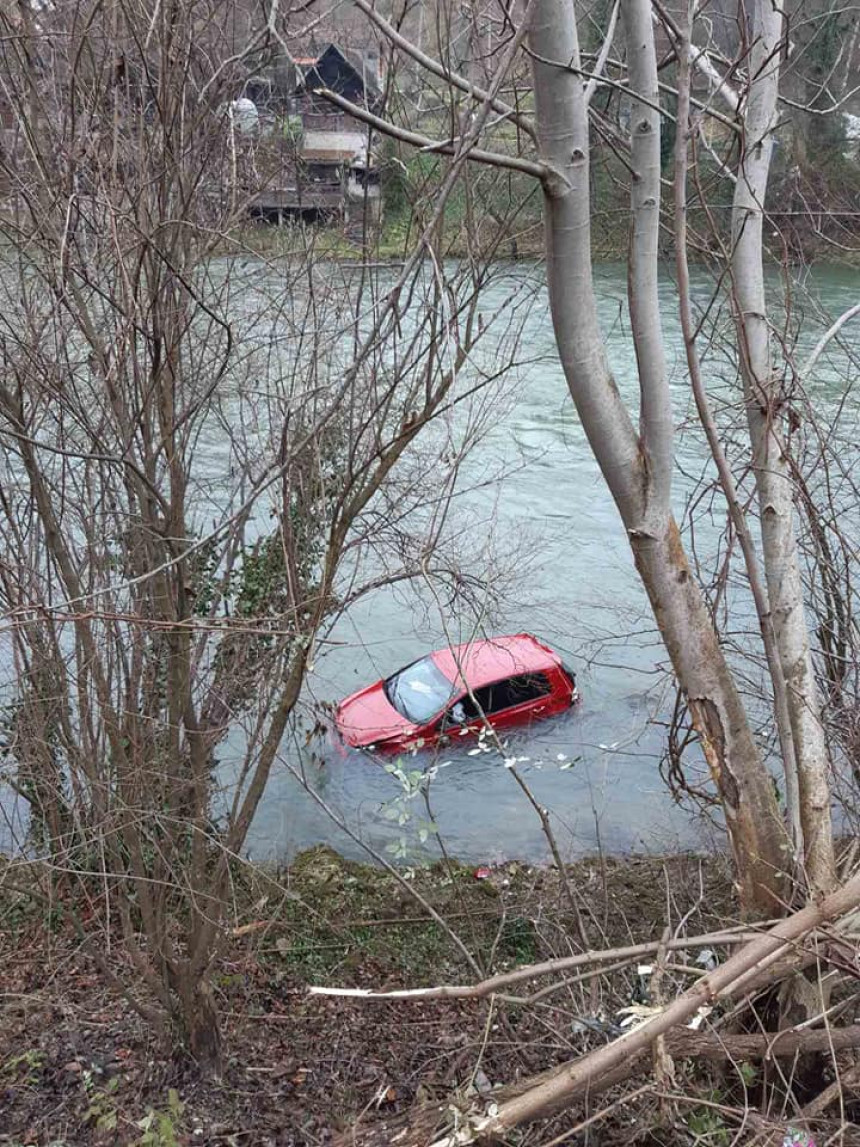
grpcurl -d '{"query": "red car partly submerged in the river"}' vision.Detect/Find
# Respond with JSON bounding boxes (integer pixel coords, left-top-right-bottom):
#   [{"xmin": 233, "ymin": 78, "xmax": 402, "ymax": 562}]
[{"xmin": 335, "ymin": 633, "xmax": 579, "ymax": 752}]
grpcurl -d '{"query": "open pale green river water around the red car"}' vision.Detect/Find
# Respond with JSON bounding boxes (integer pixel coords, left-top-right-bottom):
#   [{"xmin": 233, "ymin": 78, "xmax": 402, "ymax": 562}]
[{"xmin": 230, "ymin": 264, "xmax": 860, "ymax": 863}]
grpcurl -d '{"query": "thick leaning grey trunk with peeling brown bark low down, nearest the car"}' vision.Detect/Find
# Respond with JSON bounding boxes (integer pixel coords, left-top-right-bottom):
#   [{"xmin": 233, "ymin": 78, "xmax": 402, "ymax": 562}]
[{"xmin": 530, "ymin": 0, "xmax": 785, "ymax": 914}]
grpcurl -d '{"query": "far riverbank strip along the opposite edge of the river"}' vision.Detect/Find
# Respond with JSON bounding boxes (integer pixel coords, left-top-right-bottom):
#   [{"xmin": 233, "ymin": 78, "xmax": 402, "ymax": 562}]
[{"xmin": 214, "ymin": 142, "xmax": 860, "ymax": 268}]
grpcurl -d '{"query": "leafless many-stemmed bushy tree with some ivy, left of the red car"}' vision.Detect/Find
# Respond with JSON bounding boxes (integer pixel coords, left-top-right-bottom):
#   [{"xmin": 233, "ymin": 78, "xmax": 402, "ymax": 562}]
[{"xmin": 0, "ymin": 0, "xmax": 536, "ymax": 1070}]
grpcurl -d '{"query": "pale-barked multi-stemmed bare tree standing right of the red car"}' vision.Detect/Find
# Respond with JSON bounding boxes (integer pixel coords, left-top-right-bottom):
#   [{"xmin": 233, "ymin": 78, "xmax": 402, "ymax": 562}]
[{"xmin": 327, "ymin": 0, "xmax": 853, "ymax": 911}]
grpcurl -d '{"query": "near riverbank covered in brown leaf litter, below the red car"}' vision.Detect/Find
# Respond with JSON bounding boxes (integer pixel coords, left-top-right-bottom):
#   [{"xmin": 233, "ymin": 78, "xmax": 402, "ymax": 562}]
[{"xmin": 0, "ymin": 848, "xmax": 735, "ymax": 1147}]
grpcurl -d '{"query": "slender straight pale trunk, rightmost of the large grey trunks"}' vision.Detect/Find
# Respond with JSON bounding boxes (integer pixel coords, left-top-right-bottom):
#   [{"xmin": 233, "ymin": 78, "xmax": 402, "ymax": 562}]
[{"xmin": 732, "ymin": 0, "xmax": 836, "ymax": 895}]
